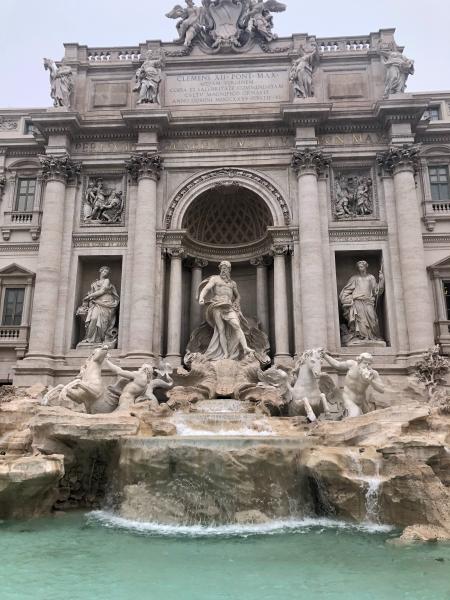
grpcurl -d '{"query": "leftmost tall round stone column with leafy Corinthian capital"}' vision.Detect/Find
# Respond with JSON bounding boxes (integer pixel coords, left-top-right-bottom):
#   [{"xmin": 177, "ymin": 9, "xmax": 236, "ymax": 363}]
[{"xmin": 27, "ymin": 155, "xmax": 81, "ymax": 359}]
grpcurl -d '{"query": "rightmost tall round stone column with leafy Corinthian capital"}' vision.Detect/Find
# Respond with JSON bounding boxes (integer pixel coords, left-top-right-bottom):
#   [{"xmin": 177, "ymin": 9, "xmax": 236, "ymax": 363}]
[{"xmin": 378, "ymin": 144, "xmax": 434, "ymax": 352}]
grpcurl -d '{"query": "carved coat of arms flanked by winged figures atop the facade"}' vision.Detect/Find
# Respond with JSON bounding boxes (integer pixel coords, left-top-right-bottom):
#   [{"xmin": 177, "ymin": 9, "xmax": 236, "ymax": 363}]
[{"xmin": 166, "ymin": 0, "xmax": 286, "ymax": 51}]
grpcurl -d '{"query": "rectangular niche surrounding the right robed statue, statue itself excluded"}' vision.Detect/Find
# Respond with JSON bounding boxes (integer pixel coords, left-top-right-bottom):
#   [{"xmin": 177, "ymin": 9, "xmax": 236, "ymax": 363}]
[{"xmin": 333, "ymin": 248, "xmax": 395, "ymax": 355}]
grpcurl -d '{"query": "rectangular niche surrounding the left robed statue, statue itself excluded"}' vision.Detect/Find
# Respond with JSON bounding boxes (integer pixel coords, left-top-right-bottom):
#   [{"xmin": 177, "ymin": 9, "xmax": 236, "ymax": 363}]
[{"xmin": 70, "ymin": 254, "xmax": 125, "ymax": 355}]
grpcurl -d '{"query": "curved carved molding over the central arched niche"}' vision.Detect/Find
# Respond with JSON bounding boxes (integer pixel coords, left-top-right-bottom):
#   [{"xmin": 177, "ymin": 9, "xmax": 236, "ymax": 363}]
[{"xmin": 165, "ymin": 167, "xmax": 291, "ymax": 229}]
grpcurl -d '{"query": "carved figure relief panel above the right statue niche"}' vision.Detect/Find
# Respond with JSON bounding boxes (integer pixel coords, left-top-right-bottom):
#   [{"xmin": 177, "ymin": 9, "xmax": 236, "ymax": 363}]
[{"xmin": 331, "ymin": 168, "xmax": 379, "ymax": 221}]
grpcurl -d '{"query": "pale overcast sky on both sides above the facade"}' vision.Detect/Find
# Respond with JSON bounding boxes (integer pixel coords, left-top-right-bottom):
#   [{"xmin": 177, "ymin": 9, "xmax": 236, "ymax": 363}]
[{"xmin": 0, "ymin": 0, "xmax": 450, "ymax": 108}]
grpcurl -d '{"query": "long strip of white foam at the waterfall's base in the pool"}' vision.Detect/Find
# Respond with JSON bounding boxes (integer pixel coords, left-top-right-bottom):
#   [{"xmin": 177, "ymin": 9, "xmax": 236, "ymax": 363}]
[{"xmin": 87, "ymin": 511, "xmax": 394, "ymax": 537}]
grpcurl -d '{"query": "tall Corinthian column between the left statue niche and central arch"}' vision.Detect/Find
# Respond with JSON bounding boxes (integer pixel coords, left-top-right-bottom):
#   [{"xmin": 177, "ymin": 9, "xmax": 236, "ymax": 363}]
[{"xmin": 127, "ymin": 152, "xmax": 162, "ymax": 359}]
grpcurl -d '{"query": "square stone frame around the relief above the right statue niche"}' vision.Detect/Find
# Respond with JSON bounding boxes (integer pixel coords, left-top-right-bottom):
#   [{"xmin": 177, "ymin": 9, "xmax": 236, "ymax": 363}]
[{"xmin": 329, "ymin": 161, "xmax": 381, "ymax": 226}]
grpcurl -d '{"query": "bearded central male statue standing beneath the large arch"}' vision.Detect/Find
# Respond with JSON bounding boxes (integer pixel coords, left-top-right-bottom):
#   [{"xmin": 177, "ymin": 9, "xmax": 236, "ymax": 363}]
[{"xmin": 199, "ymin": 261, "xmax": 254, "ymax": 360}]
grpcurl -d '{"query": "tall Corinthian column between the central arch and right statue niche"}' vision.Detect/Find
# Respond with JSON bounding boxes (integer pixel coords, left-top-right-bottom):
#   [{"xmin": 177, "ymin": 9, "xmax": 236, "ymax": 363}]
[{"xmin": 292, "ymin": 148, "xmax": 330, "ymax": 349}]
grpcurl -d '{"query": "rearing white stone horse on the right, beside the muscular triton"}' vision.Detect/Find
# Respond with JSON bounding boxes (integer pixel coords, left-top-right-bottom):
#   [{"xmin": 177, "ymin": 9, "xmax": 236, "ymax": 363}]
[{"xmin": 288, "ymin": 348, "xmax": 330, "ymax": 422}]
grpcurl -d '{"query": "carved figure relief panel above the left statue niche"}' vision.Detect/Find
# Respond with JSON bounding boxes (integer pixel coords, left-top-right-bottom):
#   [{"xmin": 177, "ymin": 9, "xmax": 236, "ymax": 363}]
[{"xmin": 80, "ymin": 174, "xmax": 126, "ymax": 227}]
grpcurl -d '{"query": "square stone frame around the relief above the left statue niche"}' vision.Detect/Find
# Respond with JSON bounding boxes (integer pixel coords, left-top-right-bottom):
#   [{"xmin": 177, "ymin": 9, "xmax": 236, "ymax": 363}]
[{"xmin": 78, "ymin": 175, "xmax": 128, "ymax": 231}]
